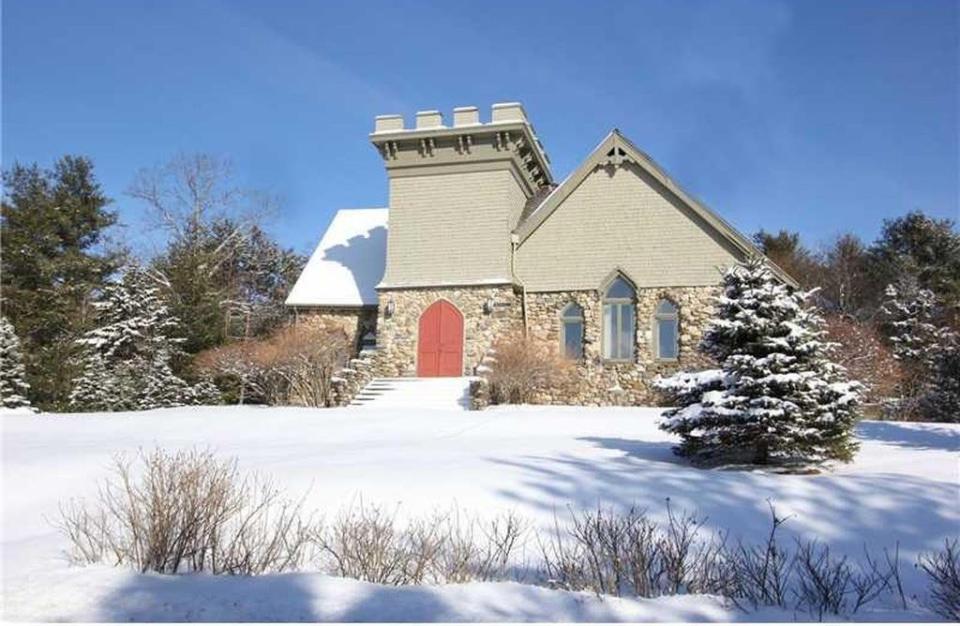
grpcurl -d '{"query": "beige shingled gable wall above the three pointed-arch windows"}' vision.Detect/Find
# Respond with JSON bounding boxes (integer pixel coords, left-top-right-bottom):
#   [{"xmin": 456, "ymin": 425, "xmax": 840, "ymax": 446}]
[{"xmin": 517, "ymin": 163, "xmax": 741, "ymax": 291}]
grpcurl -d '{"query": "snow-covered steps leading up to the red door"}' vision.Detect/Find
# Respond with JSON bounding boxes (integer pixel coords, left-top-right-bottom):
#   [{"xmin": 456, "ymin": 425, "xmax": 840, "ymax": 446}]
[{"xmin": 350, "ymin": 377, "xmax": 471, "ymax": 411}]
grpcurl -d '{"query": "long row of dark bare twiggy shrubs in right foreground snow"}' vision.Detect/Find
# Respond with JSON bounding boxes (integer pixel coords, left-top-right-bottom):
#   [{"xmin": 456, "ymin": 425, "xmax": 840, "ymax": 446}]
[{"xmin": 538, "ymin": 500, "xmax": 905, "ymax": 619}]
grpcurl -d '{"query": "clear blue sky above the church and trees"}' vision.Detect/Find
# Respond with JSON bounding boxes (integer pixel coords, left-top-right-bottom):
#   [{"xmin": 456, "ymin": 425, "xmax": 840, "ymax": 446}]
[{"xmin": 2, "ymin": 0, "xmax": 960, "ymax": 251}]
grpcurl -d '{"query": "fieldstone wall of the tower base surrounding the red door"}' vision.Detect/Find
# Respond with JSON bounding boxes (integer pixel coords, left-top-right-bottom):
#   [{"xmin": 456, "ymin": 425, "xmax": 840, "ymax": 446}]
[{"xmin": 377, "ymin": 285, "xmax": 522, "ymax": 376}]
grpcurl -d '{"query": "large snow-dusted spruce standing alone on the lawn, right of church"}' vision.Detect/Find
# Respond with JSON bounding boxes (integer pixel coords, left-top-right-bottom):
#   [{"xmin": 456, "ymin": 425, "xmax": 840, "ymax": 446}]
[{"xmin": 656, "ymin": 259, "xmax": 862, "ymax": 464}]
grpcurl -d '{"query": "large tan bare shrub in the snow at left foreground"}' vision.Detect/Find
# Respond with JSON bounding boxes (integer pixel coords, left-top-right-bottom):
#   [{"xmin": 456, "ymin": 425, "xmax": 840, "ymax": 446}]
[{"xmin": 59, "ymin": 449, "xmax": 309, "ymax": 574}]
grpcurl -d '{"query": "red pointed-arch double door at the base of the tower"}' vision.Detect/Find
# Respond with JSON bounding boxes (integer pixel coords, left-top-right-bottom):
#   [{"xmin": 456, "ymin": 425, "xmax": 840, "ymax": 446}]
[{"xmin": 417, "ymin": 300, "xmax": 463, "ymax": 376}]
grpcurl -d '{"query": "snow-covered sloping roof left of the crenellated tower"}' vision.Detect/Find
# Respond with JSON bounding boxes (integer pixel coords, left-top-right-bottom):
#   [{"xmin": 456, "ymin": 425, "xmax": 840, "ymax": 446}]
[{"xmin": 287, "ymin": 209, "xmax": 388, "ymax": 306}]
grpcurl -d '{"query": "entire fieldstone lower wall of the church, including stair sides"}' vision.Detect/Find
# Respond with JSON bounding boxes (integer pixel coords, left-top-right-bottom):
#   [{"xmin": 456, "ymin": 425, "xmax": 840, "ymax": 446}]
[{"xmin": 297, "ymin": 285, "xmax": 720, "ymax": 408}]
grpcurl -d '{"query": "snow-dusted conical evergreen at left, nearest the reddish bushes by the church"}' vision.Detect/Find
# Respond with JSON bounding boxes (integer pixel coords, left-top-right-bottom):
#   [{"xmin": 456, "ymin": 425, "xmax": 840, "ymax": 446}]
[{"xmin": 70, "ymin": 266, "xmax": 219, "ymax": 411}]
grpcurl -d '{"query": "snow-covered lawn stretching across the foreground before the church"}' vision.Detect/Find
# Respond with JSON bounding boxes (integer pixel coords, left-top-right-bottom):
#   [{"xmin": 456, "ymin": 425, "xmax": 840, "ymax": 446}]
[{"xmin": 0, "ymin": 407, "xmax": 960, "ymax": 621}]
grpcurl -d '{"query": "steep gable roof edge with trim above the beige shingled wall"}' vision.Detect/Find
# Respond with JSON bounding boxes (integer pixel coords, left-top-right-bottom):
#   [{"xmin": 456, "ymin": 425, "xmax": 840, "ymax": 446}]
[{"xmin": 514, "ymin": 129, "xmax": 797, "ymax": 286}]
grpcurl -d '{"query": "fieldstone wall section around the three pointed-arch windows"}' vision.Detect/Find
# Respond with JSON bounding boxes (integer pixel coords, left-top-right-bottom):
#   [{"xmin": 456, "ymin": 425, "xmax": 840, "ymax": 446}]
[{"xmin": 527, "ymin": 287, "xmax": 719, "ymax": 405}]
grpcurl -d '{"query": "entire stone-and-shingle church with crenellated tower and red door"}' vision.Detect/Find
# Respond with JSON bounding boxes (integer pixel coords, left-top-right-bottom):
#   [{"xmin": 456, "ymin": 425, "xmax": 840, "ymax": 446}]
[{"xmin": 287, "ymin": 103, "xmax": 793, "ymax": 404}]
